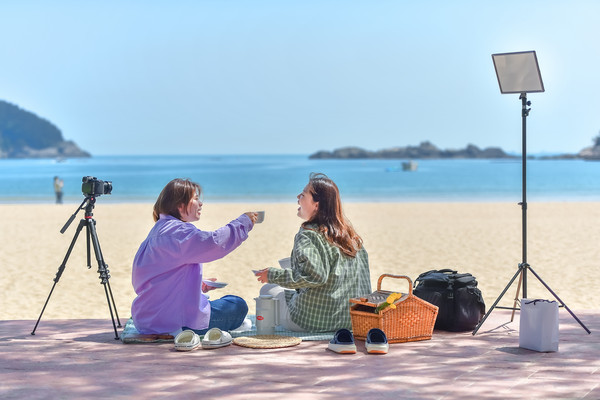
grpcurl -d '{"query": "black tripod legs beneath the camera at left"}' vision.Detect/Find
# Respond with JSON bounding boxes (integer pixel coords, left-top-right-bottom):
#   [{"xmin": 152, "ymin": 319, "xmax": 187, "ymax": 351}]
[{"xmin": 31, "ymin": 195, "xmax": 121, "ymax": 339}]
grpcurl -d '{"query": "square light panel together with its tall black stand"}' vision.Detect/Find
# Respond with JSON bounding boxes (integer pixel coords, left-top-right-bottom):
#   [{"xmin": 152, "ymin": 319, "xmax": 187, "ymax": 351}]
[{"xmin": 473, "ymin": 51, "xmax": 591, "ymax": 335}]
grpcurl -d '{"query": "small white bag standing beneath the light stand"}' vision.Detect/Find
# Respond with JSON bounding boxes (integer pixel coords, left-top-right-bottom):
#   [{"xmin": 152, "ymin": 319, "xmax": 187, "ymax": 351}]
[{"xmin": 519, "ymin": 299, "xmax": 558, "ymax": 352}]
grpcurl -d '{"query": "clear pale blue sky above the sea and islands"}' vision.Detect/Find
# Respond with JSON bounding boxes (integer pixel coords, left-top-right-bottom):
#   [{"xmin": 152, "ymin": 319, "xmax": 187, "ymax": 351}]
[{"xmin": 0, "ymin": 0, "xmax": 600, "ymax": 155}]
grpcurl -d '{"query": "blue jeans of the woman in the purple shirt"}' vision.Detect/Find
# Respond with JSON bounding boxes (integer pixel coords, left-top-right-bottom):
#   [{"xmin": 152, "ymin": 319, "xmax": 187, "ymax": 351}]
[{"xmin": 183, "ymin": 295, "xmax": 248, "ymax": 335}]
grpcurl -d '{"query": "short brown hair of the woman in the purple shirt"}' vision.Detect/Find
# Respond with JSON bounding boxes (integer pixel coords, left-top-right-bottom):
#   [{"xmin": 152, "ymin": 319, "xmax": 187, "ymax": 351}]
[{"xmin": 152, "ymin": 178, "xmax": 202, "ymax": 222}]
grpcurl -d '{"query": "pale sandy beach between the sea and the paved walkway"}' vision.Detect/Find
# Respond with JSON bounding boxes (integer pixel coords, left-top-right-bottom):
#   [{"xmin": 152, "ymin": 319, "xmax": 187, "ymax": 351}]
[{"xmin": 0, "ymin": 199, "xmax": 600, "ymax": 320}]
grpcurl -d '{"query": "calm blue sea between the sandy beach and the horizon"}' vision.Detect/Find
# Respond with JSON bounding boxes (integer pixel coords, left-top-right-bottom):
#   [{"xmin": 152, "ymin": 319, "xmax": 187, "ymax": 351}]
[{"xmin": 0, "ymin": 155, "xmax": 600, "ymax": 204}]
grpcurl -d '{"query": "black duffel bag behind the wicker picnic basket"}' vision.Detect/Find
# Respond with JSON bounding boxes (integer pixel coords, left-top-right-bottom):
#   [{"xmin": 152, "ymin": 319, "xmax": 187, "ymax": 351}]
[{"xmin": 413, "ymin": 269, "xmax": 485, "ymax": 332}]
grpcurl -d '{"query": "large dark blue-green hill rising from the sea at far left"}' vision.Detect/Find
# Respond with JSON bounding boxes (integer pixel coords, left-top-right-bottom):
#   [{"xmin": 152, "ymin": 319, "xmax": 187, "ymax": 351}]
[{"xmin": 0, "ymin": 100, "xmax": 91, "ymax": 159}]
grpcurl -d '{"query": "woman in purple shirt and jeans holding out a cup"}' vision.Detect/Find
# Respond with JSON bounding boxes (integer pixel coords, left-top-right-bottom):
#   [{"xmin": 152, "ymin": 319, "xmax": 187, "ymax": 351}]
[{"xmin": 131, "ymin": 179, "xmax": 258, "ymax": 336}]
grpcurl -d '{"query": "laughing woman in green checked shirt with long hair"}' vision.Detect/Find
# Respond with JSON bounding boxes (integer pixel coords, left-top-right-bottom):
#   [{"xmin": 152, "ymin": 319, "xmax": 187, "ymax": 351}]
[{"xmin": 256, "ymin": 173, "xmax": 371, "ymax": 332}]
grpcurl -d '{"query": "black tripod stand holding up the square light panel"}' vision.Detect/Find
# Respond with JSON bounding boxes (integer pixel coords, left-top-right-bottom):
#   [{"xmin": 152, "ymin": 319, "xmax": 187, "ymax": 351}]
[{"xmin": 473, "ymin": 93, "xmax": 591, "ymax": 335}]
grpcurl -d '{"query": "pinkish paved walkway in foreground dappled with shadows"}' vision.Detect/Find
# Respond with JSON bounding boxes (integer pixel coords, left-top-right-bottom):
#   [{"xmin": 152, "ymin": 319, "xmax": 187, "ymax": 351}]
[{"xmin": 0, "ymin": 309, "xmax": 600, "ymax": 400}]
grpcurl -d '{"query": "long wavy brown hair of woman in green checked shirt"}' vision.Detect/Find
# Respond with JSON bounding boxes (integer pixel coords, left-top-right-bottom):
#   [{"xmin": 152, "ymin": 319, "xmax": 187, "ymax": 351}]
[{"xmin": 302, "ymin": 172, "xmax": 363, "ymax": 257}]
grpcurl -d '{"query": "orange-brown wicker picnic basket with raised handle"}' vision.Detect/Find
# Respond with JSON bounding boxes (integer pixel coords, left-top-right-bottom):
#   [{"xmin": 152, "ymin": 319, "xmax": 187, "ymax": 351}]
[{"xmin": 350, "ymin": 274, "xmax": 438, "ymax": 343}]
